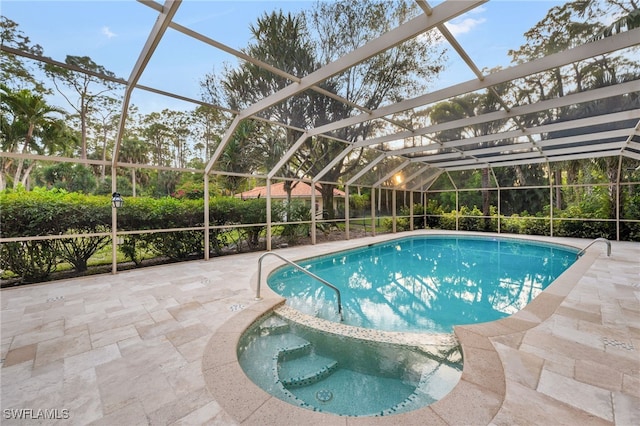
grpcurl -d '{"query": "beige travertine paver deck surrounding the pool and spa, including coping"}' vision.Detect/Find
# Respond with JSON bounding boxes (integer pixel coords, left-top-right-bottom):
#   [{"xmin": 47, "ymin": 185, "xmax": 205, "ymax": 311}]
[{"xmin": 0, "ymin": 231, "xmax": 640, "ymax": 425}]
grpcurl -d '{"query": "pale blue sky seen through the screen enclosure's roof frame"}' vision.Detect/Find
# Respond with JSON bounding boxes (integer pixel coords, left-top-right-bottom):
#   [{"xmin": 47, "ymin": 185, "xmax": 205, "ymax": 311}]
[{"xmin": 0, "ymin": 0, "xmax": 564, "ymax": 113}]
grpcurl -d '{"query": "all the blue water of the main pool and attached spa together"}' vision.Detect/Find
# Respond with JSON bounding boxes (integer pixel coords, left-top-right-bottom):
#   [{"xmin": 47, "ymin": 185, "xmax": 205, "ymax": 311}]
[{"xmin": 237, "ymin": 236, "xmax": 578, "ymax": 416}]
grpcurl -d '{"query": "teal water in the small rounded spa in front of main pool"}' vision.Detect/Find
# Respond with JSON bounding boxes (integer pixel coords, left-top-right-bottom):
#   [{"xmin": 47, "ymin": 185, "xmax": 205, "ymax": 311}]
[{"xmin": 238, "ymin": 314, "xmax": 462, "ymax": 416}]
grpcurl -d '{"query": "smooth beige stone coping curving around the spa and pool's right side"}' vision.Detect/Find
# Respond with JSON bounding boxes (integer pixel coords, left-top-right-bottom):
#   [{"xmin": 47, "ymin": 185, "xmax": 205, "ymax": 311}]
[{"xmin": 202, "ymin": 232, "xmax": 598, "ymax": 425}]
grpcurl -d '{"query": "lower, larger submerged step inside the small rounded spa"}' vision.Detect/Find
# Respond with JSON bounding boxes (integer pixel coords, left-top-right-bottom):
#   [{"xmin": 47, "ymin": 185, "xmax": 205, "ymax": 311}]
[{"xmin": 278, "ymin": 353, "xmax": 338, "ymax": 388}]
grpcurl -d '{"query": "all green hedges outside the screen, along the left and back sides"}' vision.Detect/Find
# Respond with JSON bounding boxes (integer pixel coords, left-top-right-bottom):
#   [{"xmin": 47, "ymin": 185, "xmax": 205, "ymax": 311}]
[{"xmin": 0, "ymin": 188, "xmax": 640, "ymax": 282}]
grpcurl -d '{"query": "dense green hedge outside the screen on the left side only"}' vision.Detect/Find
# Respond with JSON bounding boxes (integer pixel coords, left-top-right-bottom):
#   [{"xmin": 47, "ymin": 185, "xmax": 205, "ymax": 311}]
[{"xmin": 0, "ymin": 189, "xmax": 282, "ymax": 282}]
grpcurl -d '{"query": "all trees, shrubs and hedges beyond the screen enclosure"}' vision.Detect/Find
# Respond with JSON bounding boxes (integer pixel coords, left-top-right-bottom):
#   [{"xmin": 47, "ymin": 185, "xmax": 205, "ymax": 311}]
[{"xmin": 0, "ymin": 0, "xmax": 640, "ymax": 281}]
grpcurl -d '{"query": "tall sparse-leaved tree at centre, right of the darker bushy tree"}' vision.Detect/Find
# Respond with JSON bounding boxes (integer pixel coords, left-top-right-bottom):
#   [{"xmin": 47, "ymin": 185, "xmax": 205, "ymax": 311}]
[{"xmin": 303, "ymin": 0, "xmax": 445, "ymax": 217}]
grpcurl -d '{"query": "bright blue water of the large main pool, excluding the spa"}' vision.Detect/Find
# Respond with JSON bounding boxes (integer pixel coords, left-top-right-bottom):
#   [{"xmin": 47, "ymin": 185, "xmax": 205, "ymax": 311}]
[{"xmin": 267, "ymin": 236, "xmax": 577, "ymax": 333}]
